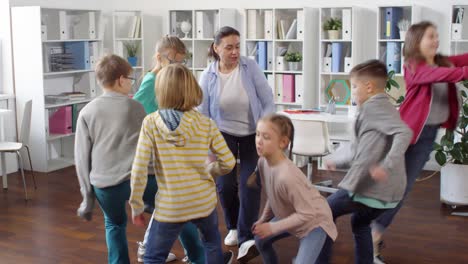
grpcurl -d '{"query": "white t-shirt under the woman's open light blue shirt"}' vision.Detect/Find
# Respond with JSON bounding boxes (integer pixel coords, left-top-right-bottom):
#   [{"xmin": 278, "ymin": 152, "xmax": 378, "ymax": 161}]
[{"xmin": 218, "ymin": 65, "xmax": 255, "ymax": 136}]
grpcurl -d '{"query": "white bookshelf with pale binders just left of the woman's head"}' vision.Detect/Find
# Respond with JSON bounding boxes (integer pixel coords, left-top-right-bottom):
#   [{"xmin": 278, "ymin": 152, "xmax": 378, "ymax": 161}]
[{"xmin": 168, "ymin": 8, "xmax": 239, "ymax": 78}]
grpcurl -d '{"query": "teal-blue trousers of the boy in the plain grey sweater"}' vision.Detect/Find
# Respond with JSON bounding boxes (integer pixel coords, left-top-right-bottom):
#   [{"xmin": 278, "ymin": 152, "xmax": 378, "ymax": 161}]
[{"xmin": 93, "ymin": 180, "xmax": 130, "ymax": 264}]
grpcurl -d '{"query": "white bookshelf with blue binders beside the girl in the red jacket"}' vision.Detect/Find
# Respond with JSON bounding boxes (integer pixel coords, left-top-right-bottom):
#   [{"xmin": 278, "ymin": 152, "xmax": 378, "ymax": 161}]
[{"xmin": 376, "ymin": 5, "xmax": 421, "ymax": 103}]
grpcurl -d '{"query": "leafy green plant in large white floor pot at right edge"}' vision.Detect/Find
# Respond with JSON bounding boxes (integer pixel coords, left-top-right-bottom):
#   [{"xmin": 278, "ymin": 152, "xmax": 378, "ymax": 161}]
[{"xmin": 434, "ymin": 84, "xmax": 468, "ymax": 208}]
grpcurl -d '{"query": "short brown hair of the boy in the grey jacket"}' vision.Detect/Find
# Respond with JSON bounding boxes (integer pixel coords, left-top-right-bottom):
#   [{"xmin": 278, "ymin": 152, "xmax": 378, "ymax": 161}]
[{"xmin": 349, "ymin": 60, "xmax": 388, "ymax": 89}]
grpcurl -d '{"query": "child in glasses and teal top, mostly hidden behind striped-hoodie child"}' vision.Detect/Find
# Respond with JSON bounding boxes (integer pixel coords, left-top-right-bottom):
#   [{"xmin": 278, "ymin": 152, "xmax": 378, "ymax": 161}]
[{"xmin": 133, "ymin": 36, "xmax": 205, "ymax": 264}]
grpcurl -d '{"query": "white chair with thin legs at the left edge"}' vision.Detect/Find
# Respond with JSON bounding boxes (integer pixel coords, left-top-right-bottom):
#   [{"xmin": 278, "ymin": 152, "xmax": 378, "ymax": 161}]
[{"xmin": 0, "ymin": 100, "xmax": 37, "ymax": 200}]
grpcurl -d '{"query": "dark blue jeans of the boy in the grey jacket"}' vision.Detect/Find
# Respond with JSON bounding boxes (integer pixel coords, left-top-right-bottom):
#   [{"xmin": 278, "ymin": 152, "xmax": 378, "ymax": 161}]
[{"xmin": 317, "ymin": 189, "xmax": 387, "ymax": 264}]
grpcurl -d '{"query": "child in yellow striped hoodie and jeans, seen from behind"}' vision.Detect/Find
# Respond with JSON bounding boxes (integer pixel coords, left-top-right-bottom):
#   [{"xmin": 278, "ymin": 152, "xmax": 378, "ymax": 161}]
[{"xmin": 129, "ymin": 64, "xmax": 235, "ymax": 264}]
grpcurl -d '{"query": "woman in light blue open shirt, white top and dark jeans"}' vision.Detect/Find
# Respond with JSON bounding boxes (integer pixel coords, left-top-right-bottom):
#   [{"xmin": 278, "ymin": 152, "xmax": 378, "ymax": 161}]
[{"xmin": 199, "ymin": 27, "xmax": 275, "ymax": 263}]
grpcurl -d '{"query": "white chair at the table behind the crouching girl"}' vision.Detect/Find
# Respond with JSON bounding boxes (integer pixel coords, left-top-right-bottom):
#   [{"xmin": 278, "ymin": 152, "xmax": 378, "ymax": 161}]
[{"xmin": 291, "ymin": 119, "xmax": 337, "ymax": 193}]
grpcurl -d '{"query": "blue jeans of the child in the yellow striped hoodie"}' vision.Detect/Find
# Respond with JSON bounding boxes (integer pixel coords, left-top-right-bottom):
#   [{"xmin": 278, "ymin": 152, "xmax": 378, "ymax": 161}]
[{"xmin": 144, "ymin": 209, "xmax": 223, "ymax": 264}]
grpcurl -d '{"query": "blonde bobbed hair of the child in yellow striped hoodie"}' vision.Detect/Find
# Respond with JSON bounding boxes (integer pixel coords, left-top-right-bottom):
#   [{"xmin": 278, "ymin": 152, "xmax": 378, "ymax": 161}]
[{"xmin": 155, "ymin": 64, "xmax": 203, "ymax": 111}]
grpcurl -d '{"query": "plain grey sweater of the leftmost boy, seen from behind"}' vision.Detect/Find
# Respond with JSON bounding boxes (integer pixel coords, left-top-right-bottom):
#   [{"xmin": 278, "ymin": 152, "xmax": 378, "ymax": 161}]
[{"xmin": 75, "ymin": 91, "xmax": 146, "ymax": 219}]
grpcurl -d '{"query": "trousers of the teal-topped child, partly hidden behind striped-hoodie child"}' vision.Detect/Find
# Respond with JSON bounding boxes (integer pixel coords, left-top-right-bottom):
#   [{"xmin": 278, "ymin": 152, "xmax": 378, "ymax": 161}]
[{"xmin": 143, "ymin": 175, "xmax": 205, "ymax": 264}]
